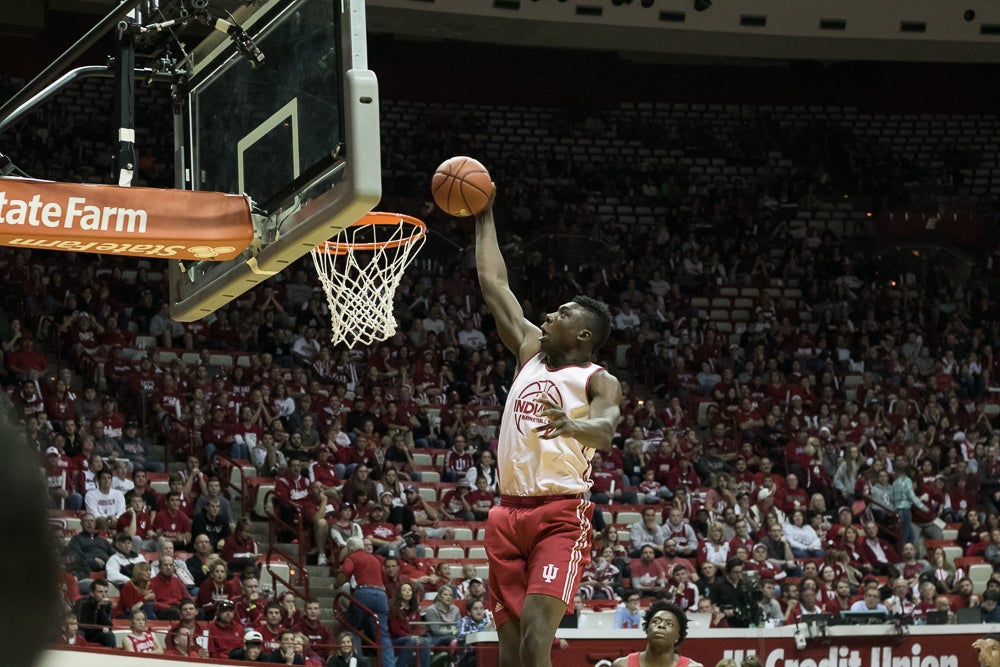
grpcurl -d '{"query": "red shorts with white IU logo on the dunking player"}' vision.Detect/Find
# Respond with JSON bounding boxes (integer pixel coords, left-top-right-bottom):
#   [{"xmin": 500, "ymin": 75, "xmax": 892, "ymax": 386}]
[{"xmin": 485, "ymin": 497, "xmax": 594, "ymax": 627}]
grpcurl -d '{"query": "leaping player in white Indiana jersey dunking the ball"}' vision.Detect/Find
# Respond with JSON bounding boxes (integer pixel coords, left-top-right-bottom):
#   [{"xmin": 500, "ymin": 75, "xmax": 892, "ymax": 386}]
[{"xmin": 476, "ymin": 190, "xmax": 621, "ymax": 667}]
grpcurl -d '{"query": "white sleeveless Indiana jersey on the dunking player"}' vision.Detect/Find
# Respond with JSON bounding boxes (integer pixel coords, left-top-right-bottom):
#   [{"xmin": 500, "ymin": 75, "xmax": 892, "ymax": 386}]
[{"xmin": 497, "ymin": 353, "xmax": 603, "ymax": 496}]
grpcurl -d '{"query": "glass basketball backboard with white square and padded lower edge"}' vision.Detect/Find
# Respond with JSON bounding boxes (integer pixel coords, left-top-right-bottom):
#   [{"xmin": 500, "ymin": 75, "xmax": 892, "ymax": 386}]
[{"xmin": 170, "ymin": 0, "xmax": 381, "ymax": 322}]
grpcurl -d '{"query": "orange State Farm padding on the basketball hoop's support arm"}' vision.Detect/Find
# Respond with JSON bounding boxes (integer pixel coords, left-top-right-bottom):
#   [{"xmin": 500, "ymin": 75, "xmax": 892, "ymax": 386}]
[{"xmin": 0, "ymin": 178, "xmax": 253, "ymax": 261}]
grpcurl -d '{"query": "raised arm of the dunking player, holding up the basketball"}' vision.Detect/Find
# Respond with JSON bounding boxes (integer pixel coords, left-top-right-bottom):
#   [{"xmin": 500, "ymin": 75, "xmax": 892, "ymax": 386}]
[{"xmin": 476, "ymin": 190, "xmax": 541, "ymax": 363}]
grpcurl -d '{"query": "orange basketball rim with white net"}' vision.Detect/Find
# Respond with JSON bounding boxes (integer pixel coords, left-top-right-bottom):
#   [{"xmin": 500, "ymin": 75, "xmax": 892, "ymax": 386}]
[{"xmin": 312, "ymin": 212, "xmax": 427, "ymax": 348}]
